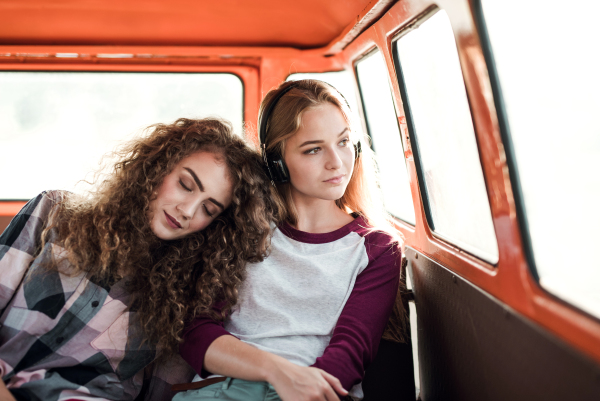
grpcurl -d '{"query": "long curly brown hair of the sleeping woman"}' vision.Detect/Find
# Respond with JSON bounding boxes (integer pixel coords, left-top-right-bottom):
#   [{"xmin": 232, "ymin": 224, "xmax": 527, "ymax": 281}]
[{"xmin": 42, "ymin": 118, "xmax": 281, "ymax": 354}]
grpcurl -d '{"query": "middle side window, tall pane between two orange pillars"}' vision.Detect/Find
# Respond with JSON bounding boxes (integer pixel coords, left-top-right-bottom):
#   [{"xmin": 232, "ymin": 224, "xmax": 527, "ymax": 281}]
[{"xmin": 395, "ymin": 10, "xmax": 498, "ymax": 263}]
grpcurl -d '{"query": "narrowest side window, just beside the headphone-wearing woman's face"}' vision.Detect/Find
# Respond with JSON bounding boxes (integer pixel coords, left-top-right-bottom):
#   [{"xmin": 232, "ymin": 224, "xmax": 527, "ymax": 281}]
[{"xmin": 356, "ymin": 50, "xmax": 415, "ymax": 224}]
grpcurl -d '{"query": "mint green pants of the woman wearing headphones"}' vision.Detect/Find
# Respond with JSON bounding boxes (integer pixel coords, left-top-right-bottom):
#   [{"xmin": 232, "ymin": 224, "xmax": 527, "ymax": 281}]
[{"xmin": 173, "ymin": 377, "xmax": 281, "ymax": 401}]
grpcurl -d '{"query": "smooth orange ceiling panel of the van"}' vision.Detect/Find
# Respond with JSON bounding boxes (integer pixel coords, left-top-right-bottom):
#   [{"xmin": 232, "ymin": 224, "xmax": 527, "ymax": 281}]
[{"xmin": 0, "ymin": 0, "xmax": 377, "ymax": 49}]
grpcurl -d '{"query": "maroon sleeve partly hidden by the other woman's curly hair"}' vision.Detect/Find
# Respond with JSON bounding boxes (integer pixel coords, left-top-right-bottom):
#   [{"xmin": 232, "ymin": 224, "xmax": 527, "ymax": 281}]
[{"xmin": 179, "ymin": 302, "xmax": 237, "ymax": 378}]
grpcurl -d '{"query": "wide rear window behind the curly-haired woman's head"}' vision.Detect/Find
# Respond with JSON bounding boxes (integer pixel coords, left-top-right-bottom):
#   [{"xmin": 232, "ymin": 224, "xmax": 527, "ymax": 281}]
[{"xmin": 0, "ymin": 71, "xmax": 243, "ymax": 199}]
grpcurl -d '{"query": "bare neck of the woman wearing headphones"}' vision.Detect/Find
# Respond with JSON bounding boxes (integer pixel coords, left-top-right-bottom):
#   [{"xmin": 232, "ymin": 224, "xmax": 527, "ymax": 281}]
[{"xmin": 292, "ymin": 191, "xmax": 354, "ymax": 234}]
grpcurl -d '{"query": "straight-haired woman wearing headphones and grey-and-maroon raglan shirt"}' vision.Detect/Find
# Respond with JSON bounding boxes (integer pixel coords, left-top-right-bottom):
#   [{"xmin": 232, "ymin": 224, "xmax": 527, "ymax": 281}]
[{"xmin": 174, "ymin": 80, "xmax": 405, "ymax": 401}]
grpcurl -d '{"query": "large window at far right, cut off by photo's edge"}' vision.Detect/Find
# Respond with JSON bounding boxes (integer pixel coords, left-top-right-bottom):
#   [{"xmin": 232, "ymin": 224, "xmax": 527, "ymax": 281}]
[{"xmin": 482, "ymin": 0, "xmax": 600, "ymax": 317}]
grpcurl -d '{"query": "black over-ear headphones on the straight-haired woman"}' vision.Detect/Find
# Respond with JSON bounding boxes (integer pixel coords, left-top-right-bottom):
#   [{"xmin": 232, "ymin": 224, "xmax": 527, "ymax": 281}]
[{"xmin": 258, "ymin": 80, "xmax": 362, "ymax": 184}]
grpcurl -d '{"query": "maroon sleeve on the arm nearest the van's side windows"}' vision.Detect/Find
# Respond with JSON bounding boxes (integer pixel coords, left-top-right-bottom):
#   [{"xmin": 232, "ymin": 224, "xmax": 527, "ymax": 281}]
[{"xmin": 312, "ymin": 233, "xmax": 401, "ymax": 390}]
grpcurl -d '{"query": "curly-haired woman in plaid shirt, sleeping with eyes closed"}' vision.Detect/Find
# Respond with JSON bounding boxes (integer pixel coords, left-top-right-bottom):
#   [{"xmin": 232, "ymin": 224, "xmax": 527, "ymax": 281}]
[{"xmin": 0, "ymin": 119, "xmax": 277, "ymax": 401}]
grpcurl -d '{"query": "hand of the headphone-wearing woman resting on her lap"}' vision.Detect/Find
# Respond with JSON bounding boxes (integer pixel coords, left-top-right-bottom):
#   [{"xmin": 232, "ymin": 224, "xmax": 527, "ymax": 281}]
[{"xmin": 269, "ymin": 360, "xmax": 348, "ymax": 401}]
